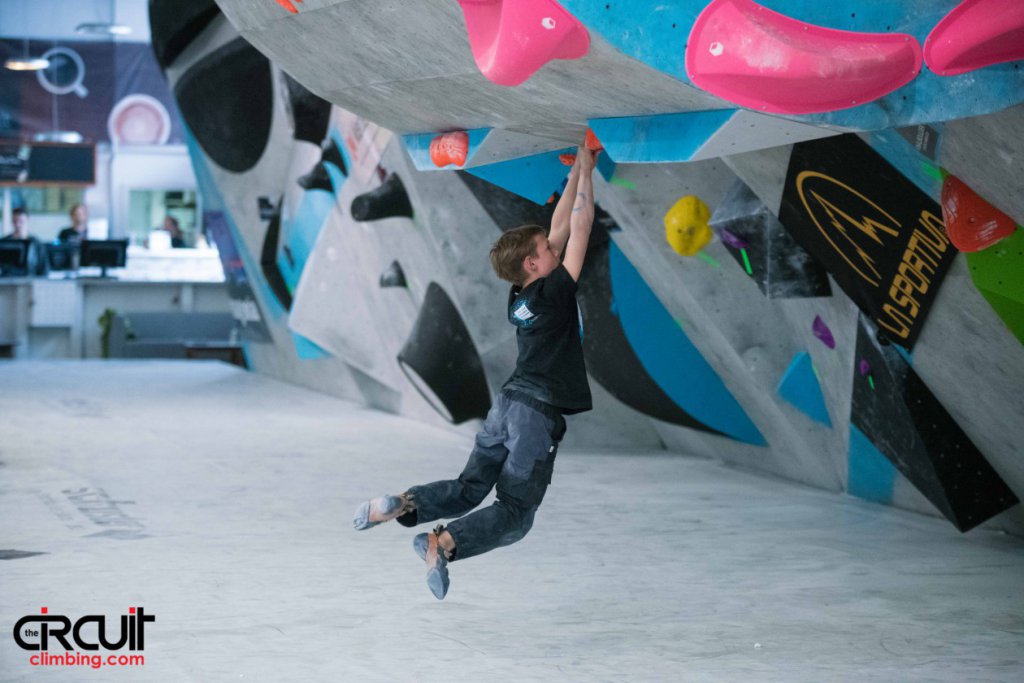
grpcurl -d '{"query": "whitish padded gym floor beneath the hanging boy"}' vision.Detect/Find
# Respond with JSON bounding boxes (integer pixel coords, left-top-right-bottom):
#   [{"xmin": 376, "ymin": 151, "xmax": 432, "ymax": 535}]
[{"xmin": 0, "ymin": 361, "xmax": 1024, "ymax": 682}]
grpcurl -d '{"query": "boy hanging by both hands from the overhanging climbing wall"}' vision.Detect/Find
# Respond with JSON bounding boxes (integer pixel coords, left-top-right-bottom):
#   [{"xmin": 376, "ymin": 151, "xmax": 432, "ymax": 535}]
[{"xmin": 352, "ymin": 145, "xmax": 598, "ymax": 600}]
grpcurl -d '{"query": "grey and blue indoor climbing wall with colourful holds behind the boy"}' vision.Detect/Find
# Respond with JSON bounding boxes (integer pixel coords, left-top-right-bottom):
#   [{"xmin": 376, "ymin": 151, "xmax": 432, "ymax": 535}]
[{"xmin": 151, "ymin": 0, "xmax": 1024, "ymax": 532}]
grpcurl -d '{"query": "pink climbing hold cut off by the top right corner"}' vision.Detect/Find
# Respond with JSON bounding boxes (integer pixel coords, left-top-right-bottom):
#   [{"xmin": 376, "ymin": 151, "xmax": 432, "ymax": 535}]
[{"xmin": 925, "ymin": 0, "xmax": 1024, "ymax": 76}]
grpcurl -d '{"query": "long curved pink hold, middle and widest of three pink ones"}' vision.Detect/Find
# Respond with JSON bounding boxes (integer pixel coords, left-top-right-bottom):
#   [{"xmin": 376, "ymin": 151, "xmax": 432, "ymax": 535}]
[{"xmin": 686, "ymin": 0, "xmax": 922, "ymax": 114}]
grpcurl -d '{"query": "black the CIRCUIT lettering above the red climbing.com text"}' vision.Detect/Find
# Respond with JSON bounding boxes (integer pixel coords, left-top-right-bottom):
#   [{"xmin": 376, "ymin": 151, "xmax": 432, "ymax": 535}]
[{"xmin": 14, "ymin": 607, "xmax": 157, "ymax": 651}]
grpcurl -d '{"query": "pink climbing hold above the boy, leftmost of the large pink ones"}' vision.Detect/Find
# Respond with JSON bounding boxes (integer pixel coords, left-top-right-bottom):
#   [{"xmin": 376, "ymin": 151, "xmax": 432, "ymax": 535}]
[{"xmin": 459, "ymin": 0, "xmax": 590, "ymax": 85}]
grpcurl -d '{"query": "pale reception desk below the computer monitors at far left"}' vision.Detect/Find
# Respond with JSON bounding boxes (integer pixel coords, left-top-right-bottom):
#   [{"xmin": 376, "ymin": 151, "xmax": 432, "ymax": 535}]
[{"xmin": 0, "ymin": 278, "xmax": 230, "ymax": 358}]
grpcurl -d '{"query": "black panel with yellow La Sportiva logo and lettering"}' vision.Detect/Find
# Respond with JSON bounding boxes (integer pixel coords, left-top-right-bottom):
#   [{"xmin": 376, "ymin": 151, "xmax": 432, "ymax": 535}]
[{"xmin": 779, "ymin": 135, "xmax": 956, "ymax": 349}]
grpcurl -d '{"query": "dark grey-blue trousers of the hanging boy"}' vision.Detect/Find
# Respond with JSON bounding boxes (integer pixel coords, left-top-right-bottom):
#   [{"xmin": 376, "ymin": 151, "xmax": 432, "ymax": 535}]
[{"xmin": 398, "ymin": 392, "xmax": 565, "ymax": 560}]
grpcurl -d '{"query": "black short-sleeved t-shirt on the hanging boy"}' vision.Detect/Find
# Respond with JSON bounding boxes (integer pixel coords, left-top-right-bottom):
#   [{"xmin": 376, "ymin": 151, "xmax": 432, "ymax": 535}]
[{"xmin": 502, "ymin": 263, "xmax": 593, "ymax": 415}]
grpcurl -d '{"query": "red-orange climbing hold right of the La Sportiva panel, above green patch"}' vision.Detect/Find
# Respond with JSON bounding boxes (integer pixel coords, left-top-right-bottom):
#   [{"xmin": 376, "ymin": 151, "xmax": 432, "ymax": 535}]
[{"xmin": 942, "ymin": 175, "xmax": 1017, "ymax": 252}]
